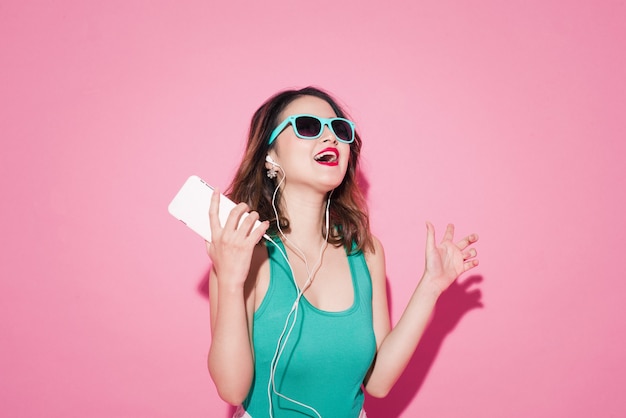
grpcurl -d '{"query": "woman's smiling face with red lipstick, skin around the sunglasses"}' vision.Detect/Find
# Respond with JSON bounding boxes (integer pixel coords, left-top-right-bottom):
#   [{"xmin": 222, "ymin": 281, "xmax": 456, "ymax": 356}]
[{"xmin": 269, "ymin": 96, "xmax": 351, "ymax": 193}]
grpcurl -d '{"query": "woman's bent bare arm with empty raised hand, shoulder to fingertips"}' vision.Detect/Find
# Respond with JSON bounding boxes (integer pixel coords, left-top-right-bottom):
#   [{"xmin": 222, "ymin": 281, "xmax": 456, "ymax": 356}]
[{"xmin": 365, "ymin": 223, "xmax": 478, "ymax": 397}]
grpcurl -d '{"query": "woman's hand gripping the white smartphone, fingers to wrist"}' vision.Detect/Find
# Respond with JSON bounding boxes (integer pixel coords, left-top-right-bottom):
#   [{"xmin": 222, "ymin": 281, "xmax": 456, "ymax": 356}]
[{"xmin": 206, "ymin": 189, "xmax": 269, "ymax": 286}]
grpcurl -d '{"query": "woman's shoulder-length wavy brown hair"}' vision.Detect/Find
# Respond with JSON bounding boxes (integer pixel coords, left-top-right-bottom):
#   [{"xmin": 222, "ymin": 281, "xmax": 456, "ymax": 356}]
[{"xmin": 228, "ymin": 87, "xmax": 374, "ymax": 252}]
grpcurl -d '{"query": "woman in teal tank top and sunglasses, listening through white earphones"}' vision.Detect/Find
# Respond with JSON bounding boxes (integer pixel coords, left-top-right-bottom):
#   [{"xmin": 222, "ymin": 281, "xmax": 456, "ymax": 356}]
[{"xmin": 207, "ymin": 87, "xmax": 478, "ymax": 418}]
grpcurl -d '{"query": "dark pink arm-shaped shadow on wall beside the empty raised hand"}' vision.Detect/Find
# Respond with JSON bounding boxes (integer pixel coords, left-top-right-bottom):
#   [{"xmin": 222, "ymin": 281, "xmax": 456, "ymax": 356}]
[{"xmin": 365, "ymin": 276, "xmax": 483, "ymax": 418}]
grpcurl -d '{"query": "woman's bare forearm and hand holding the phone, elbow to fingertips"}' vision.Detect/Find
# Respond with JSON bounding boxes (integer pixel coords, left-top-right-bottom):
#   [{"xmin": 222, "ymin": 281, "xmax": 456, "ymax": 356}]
[{"xmin": 202, "ymin": 192, "xmax": 267, "ymax": 405}]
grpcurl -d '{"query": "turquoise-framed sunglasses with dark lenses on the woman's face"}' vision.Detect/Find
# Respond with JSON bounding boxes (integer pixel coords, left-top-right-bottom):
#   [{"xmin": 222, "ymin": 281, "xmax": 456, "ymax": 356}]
[{"xmin": 268, "ymin": 115, "xmax": 354, "ymax": 144}]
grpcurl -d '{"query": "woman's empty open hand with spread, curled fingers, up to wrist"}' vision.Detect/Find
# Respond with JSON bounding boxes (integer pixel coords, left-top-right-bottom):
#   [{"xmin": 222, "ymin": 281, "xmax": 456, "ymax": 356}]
[{"xmin": 423, "ymin": 222, "xmax": 478, "ymax": 292}]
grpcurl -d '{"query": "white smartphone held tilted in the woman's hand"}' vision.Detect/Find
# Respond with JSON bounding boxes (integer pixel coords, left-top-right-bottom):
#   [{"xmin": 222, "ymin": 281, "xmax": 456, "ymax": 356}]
[{"xmin": 167, "ymin": 176, "xmax": 261, "ymax": 242}]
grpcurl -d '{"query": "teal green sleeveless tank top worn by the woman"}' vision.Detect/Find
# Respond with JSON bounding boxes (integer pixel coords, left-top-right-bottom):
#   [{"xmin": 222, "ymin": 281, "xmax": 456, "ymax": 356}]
[{"xmin": 243, "ymin": 238, "xmax": 376, "ymax": 418}]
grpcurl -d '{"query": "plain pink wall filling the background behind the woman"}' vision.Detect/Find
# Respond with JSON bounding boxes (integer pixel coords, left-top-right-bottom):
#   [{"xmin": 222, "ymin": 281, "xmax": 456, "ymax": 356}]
[{"xmin": 0, "ymin": 0, "xmax": 626, "ymax": 418}]
